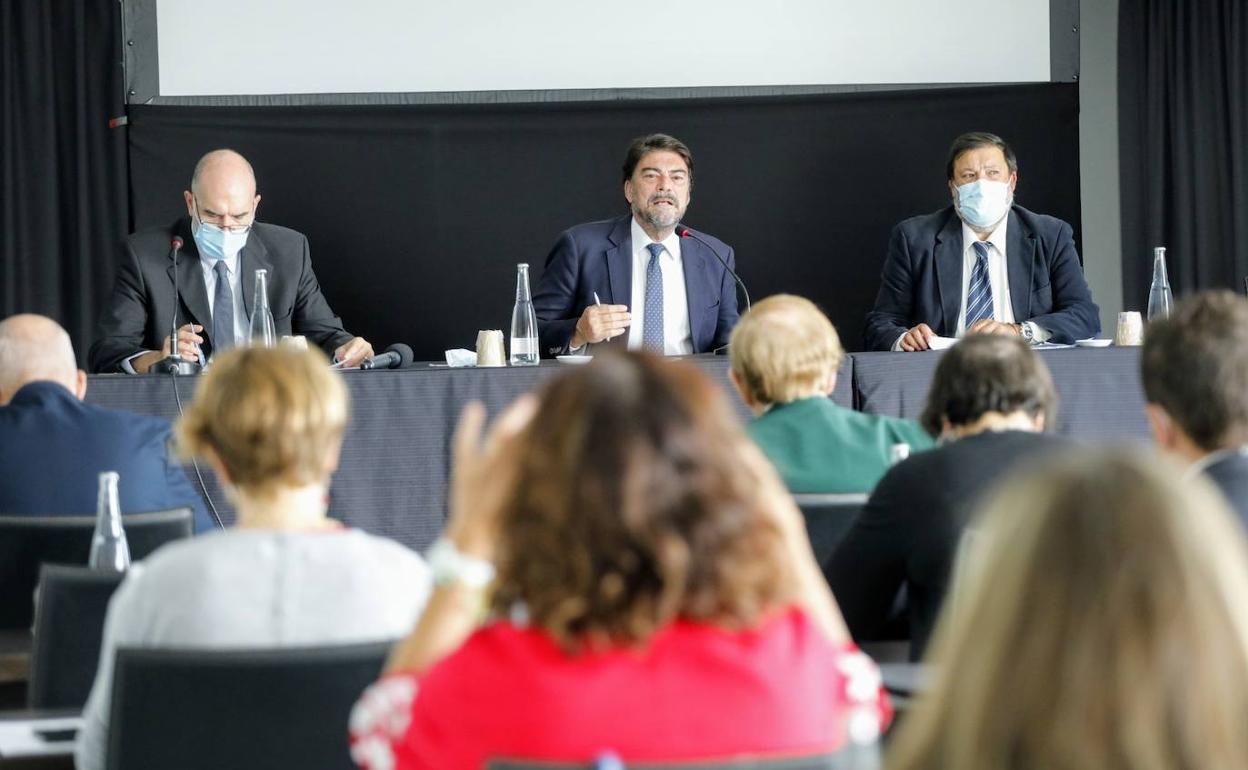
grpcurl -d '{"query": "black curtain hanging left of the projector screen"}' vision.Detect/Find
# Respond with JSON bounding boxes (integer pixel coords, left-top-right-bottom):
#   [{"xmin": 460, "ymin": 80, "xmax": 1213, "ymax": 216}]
[{"xmin": 0, "ymin": 0, "xmax": 130, "ymax": 363}]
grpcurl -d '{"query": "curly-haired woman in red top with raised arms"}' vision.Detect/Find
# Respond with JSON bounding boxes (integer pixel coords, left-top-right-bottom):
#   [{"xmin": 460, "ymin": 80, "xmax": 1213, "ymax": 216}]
[{"xmin": 351, "ymin": 353, "xmax": 890, "ymax": 770}]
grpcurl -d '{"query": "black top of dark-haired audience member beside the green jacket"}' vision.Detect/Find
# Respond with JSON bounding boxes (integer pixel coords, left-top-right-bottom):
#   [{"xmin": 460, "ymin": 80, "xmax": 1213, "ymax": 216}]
[{"xmin": 825, "ymin": 431, "xmax": 1068, "ymax": 660}]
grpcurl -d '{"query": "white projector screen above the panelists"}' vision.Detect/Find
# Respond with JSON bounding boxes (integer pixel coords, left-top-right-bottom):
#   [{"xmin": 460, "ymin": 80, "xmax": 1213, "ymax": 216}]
[{"xmin": 151, "ymin": 0, "xmax": 1057, "ymax": 96}]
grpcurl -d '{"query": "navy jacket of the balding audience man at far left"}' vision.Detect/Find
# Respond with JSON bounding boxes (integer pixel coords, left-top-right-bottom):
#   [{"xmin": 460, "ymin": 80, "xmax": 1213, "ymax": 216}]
[{"xmin": 0, "ymin": 382, "xmax": 212, "ymax": 532}]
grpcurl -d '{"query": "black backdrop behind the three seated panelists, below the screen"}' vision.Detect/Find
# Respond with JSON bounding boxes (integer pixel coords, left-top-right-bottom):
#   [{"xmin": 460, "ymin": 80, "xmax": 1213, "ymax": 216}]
[{"xmin": 130, "ymin": 84, "xmax": 1080, "ymax": 359}]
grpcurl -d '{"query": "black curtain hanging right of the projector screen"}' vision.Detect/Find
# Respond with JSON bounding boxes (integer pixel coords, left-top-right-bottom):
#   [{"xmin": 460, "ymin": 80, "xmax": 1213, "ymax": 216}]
[{"xmin": 1118, "ymin": 0, "xmax": 1248, "ymax": 308}]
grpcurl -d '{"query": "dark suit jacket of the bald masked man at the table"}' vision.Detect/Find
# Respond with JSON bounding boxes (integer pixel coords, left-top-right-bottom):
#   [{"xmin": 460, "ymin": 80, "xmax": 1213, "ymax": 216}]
[{"xmin": 87, "ymin": 217, "xmax": 351, "ymax": 372}]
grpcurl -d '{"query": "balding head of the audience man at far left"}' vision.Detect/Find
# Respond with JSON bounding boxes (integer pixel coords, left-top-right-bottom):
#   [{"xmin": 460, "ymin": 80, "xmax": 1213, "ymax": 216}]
[{"xmin": 0, "ymin": 313, "xmax": 86, "ymax": 406}]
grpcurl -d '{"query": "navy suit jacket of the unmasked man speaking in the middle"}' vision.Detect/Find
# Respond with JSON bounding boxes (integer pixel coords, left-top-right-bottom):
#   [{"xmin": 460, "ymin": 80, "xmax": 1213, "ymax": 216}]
[{"xmin": 533, "ymin": 213, "xmax": 738, "ymax": 356}]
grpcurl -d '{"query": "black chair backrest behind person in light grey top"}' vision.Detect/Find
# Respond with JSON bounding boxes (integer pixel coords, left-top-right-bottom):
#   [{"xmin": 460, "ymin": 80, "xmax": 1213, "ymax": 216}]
[{"xmin": 105, "ymin": 643, "xmax": 391, "ymax": 770}]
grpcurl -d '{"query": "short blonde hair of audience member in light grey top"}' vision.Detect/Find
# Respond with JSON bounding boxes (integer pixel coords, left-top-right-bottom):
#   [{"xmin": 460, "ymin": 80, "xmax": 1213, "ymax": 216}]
[{"xmin": 177, "ymin": 347, "xmax": 348, "ymax": 499}]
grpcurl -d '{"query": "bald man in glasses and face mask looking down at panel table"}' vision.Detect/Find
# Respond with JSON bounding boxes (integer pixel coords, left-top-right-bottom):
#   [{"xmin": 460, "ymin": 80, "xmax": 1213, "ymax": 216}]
[{"xmin": 87, "ymin": 150, "xmax": 373, "ymax": 374}]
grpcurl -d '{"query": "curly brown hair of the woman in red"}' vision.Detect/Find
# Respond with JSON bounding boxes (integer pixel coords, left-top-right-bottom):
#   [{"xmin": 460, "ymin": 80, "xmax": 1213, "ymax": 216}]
[{"xmin": 493, "ymin": 353, "xmax": 792, "ymax": 651}]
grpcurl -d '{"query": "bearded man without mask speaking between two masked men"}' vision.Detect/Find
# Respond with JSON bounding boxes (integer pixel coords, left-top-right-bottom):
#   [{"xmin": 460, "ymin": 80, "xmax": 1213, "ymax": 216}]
[{"xmin": 533, "ymin": 134, "xmax": 738, "ymax": 356}]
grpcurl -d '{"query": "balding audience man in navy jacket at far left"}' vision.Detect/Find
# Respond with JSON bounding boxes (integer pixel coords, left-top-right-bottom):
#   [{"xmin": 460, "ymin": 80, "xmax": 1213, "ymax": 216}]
[{"xmin": 0, "ymin": 314, "xmax": 212, "ymax": 532}]
